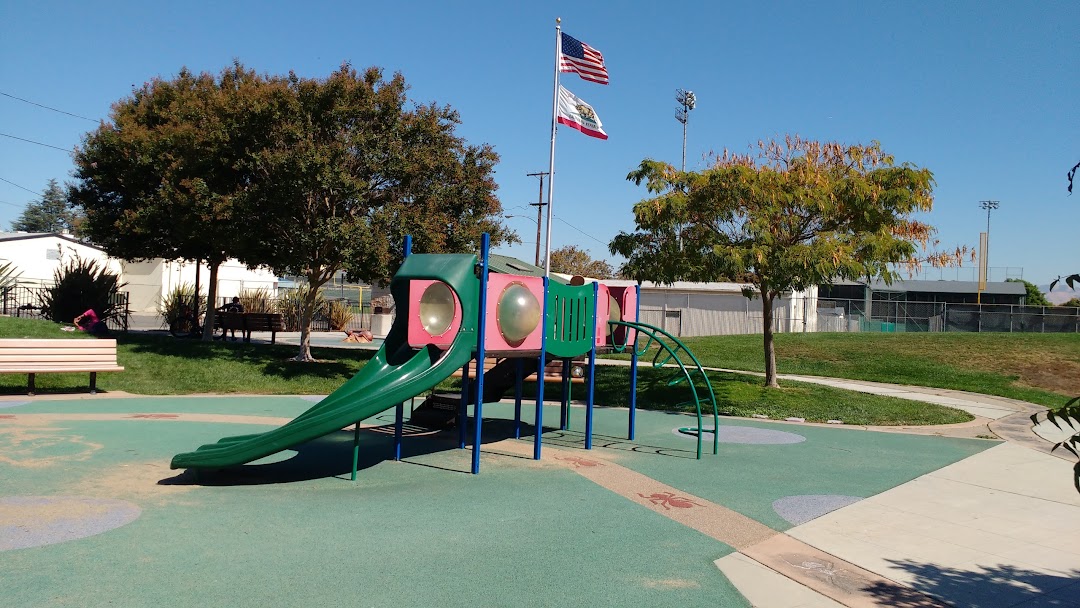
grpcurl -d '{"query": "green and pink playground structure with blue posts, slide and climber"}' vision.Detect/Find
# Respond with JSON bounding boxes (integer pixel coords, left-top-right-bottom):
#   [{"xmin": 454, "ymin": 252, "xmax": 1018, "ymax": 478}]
[{"xmin": 171, "ymin": 234, "xmax": 719, "ymax": 479}]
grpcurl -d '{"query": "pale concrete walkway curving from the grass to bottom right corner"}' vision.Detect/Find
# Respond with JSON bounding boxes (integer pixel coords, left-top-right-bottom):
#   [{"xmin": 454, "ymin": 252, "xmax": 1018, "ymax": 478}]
[{"xmin": 673, "ymin": 370, "xmax": 1080, "ymax": 608}]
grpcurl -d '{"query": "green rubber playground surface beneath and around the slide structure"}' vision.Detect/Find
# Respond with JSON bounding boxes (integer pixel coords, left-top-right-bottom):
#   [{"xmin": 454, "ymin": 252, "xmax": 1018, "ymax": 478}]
[{"xmin": 0, "ymin": 396, "xmax": 995, "ymax": 608}]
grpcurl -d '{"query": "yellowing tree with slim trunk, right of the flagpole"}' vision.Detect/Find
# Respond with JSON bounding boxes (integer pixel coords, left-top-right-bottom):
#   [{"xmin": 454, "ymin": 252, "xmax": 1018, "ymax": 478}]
[{"xmin": 610, "ymin": 136, "xmax": 966, "ymax": 387}]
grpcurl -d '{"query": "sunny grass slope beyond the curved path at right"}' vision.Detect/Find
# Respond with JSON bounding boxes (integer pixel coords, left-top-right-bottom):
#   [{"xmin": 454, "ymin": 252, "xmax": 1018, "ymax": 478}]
[{"xmin": 617, "ymin": 333, "xmax": 1080, "ymax": 406}]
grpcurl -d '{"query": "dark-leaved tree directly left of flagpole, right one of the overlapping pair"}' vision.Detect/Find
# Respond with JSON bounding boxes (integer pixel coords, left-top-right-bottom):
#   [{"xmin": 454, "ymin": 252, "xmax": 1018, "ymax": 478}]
[{"xmin": 237, "ymin": 65, "xmax": 516, "ymax": 361}]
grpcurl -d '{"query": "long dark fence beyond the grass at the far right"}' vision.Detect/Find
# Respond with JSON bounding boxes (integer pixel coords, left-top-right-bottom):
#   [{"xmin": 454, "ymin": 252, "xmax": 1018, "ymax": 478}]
[{"xmin": 807, "ymin": 298, "xmax": 1080, "ymax": 334}]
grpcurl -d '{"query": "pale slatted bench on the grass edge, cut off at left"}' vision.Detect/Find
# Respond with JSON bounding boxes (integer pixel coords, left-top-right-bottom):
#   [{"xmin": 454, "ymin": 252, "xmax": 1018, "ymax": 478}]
[{"xmin": 0, "ymin": 338, "xmax": 124, "ymax": 395}]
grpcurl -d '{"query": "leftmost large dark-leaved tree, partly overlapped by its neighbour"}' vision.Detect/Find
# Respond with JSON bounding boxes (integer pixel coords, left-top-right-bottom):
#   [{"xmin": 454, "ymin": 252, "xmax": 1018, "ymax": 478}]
[{"xmin": 70, "ymin": 63, "xmax": 265, "ymax": 340}]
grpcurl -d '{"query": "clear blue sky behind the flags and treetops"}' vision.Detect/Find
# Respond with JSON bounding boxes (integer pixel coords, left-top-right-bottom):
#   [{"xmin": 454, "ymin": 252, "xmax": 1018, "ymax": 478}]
[{"xmin": 0, "ymin": 0, "xmax": 1080, "ymax": 284}]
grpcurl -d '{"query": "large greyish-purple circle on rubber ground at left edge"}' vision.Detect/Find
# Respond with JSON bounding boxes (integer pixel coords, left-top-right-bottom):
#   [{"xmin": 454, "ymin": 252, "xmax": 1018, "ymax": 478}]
[{"xmin": 0, "ymin": 496, "xmax": 143, "ymax": 551}]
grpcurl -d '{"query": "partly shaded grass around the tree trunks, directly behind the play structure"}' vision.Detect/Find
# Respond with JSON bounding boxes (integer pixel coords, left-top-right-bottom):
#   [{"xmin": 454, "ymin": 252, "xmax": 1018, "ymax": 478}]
[{"xmin": 0, "ymin": 317, "xmax": 971, "ymax": 424}]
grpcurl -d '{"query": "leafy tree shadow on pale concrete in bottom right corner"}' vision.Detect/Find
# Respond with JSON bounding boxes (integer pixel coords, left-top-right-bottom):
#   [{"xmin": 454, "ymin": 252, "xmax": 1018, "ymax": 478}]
[{"xmin": 865, "ymin": 556, "xmax": 1080, "ymax": 608}]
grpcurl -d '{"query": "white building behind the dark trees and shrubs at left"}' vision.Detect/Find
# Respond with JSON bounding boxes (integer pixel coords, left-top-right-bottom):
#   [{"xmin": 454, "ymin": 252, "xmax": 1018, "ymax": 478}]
[{"xmin": 0, "ymin": 232, "xmax": 278, "ymax": 312}]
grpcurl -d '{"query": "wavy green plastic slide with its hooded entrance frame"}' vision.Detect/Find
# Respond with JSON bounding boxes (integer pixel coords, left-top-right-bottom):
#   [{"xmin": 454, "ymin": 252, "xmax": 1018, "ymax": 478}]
[{"xmin": 172, "ymin": 254, "xmax": 480, "ymax": 469}]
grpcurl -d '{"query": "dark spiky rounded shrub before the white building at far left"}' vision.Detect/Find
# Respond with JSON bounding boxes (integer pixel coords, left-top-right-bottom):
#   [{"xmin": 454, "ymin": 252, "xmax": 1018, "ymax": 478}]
[{"xmin": 38, "ymin": 255, "xmax": 127, "ymax": 325}]
